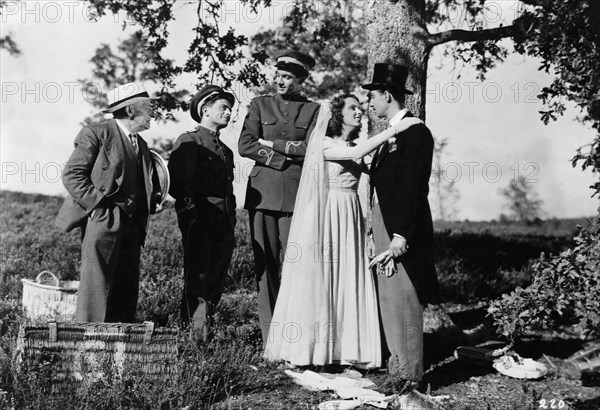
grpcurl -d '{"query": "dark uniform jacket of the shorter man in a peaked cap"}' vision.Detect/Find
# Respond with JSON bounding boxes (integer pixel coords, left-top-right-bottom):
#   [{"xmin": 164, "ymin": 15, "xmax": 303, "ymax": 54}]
[{"xmin": 169, "ymin": 126, "xmax": 235, "ymax": 215}]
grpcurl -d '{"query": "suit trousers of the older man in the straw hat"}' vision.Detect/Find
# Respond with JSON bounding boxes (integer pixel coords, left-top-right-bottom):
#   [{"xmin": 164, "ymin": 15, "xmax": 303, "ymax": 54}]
[{"xmin": 76, "ymin": 204, "xmax": 146, "ymax": 323}]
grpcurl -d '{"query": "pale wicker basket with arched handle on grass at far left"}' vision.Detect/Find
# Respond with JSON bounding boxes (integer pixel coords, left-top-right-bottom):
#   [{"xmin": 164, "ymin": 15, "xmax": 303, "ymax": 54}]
[{"xmin": 21, "ymin": 270, "xmax": 79, "ymax": 320}]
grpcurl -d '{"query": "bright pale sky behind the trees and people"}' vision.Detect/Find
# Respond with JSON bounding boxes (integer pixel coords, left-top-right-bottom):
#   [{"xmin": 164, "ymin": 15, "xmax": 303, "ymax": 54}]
[{"xmin": 0, "ymin": 1, "xmax": 599, "ymax": 220}]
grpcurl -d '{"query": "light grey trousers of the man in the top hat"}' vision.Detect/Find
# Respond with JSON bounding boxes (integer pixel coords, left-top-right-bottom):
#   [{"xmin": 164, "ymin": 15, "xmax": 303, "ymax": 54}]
[{"xmin": 372, "ymin": 204, "xmax": 423, "ymax": 381}]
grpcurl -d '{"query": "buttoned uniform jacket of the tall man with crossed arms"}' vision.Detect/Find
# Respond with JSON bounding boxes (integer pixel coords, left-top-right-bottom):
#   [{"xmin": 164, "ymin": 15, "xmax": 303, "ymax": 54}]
[{"xmin": 239, "ymin": 94, "xmax": 319, "ymax": 212}]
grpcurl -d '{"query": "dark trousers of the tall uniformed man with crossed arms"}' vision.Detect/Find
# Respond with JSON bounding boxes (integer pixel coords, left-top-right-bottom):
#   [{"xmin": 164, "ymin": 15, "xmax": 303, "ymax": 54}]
[{"xmin": 248, "ymin": 209, "xmax": 292, "ymax": 344}]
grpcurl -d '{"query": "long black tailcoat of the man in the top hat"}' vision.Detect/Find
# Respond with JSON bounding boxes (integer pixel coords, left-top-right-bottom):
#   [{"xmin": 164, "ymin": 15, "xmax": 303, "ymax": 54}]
[{"xmin": 370, "ymin": 113, "xmax": 439, "ymax": 304}]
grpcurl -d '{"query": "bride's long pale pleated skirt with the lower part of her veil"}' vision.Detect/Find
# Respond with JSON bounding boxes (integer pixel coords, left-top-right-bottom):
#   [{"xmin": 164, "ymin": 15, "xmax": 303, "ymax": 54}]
[{"xmin": 265, "ymin": 188, "xmax": 381, "ymax": 367}]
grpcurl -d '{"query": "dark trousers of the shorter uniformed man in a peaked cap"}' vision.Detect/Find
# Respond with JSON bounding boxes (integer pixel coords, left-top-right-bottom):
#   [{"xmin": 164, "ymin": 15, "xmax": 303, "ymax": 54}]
[{"xmin": 177, "ymin": 208, "xmax": 235, "ymax": 336}]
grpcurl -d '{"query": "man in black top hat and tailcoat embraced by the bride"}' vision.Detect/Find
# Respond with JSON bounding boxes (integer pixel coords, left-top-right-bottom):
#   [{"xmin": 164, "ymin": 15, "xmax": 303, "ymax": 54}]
[{"xmin": 363, "ymin": 64, "xmax": 439, "ymax": 381}]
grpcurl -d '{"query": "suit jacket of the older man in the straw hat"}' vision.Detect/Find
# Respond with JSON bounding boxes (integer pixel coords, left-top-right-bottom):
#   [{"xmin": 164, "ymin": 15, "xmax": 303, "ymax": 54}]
[{"xmin": 55, "ymin": 119, "xmax": 159, "ymax": 232}]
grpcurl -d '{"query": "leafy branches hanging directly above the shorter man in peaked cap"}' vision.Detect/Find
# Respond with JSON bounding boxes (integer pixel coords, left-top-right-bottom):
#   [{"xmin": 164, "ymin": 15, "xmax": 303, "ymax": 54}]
[{"xmin": 84, "ymin": 0, "xmax": 271, "ymax": 109}]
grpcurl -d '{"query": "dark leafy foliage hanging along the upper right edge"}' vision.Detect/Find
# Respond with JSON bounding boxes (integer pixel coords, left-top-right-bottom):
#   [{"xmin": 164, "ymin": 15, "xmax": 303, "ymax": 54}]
[{"xmin": 516, "ymin": 0, "xmax": 600, "ymax": 195}]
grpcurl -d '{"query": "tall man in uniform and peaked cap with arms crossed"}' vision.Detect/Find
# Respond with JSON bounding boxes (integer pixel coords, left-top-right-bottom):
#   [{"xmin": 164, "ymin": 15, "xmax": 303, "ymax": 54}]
[{"xmin": 239, "ymin": 50, "xmax": 319, "ymax": 342}]
